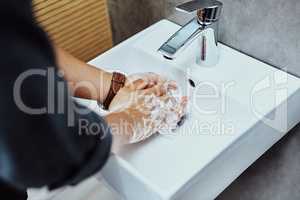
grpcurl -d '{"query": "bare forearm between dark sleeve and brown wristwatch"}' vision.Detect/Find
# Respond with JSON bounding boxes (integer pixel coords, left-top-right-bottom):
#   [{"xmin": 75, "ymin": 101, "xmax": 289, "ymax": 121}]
[{"xmin": 55, "ymin": 47, "xmax": 112, "ymax": 103}]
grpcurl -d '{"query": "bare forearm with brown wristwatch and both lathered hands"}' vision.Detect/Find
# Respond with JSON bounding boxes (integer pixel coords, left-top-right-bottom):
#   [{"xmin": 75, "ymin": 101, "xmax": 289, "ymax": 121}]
[{"xmin": 56, "ymin": 48, "xmax": 187, "ymax": 145}]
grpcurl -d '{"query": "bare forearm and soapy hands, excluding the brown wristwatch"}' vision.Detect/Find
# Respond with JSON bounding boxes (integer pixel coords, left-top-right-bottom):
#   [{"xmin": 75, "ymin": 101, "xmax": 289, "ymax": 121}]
[{"xmin": 55, "ymin": 47, "xmax": 187, "ymax": 143}]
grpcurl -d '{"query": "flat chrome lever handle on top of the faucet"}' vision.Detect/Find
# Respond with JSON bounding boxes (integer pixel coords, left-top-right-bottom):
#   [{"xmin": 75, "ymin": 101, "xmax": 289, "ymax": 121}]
[{"xmin": 176, "ymin": 0, "xmax": 223, "ymax": 25}]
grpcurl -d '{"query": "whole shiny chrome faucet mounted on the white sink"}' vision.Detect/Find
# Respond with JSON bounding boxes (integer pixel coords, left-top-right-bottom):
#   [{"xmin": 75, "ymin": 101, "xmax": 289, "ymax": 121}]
[{"xmin": 158, "ymin": 0, "xmax": 223, "ymax": 66}]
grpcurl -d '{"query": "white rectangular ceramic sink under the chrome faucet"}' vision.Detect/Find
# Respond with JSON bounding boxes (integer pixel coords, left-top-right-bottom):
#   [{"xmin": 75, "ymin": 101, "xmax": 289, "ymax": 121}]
[{"xmin": 80, "ymin": 20, "xmax": 300, "ymax": 200}]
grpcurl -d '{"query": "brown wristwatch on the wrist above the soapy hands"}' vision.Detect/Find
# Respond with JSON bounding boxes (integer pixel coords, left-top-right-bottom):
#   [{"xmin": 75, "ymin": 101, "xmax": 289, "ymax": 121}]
[{"xmin": 103, "ymin": 72, "xmax": 126, "ymax": 110}]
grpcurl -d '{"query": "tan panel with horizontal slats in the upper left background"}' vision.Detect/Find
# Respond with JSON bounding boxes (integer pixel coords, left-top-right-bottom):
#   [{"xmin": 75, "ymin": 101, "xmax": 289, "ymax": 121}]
[{"xmin": 33, "ymin": 0, "xmax": 112, "ymax": 61}]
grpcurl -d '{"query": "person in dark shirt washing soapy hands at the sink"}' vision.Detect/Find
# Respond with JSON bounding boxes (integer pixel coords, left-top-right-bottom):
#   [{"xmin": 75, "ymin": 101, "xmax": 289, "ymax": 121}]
[{"xmin": 0, "ymin": 0, "xmax": 187, "ymax": 199}]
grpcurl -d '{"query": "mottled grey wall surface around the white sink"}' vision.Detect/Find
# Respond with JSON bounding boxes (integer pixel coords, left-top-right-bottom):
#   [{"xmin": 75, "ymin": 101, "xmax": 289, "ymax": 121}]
[{"xmin": 109, "ymin": 0, "xmax": 300, "ymax": 200}]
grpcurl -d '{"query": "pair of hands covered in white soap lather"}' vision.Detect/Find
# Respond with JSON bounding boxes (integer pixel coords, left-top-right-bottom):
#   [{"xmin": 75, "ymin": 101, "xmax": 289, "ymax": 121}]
[{"xmin": 106, "ymin": 73, "xmax": 187, "ymax": 144}]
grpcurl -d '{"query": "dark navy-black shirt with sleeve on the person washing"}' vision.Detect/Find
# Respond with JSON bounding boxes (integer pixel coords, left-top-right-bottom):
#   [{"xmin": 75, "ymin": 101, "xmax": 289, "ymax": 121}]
[{"xmin": 0, "ymin": 0, "xmax": 112, "ymax": 189}]
